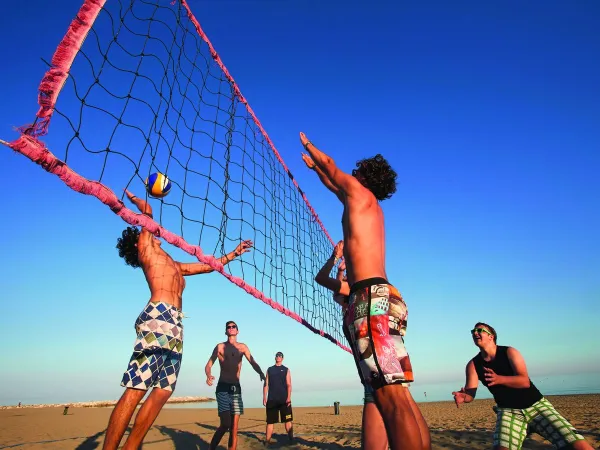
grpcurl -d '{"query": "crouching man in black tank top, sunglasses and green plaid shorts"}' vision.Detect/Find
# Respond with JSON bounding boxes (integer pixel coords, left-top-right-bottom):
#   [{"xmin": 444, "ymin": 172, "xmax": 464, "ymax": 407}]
[{"xmin": 452, "ymin": 322, "xmax": 592, "ymax": 450}]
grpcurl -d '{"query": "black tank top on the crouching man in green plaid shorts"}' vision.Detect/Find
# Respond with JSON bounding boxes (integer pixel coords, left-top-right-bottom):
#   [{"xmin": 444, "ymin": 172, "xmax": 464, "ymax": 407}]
[{"xmin": 473, "ymin": 345, "xmax": 542, "ymax": 409}]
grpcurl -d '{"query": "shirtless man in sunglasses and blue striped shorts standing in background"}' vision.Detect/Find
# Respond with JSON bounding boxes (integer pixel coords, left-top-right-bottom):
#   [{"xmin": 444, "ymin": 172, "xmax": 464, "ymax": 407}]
[{"xmin": 204, "ymin": 321, "xmax": 265, "ymax": 450}]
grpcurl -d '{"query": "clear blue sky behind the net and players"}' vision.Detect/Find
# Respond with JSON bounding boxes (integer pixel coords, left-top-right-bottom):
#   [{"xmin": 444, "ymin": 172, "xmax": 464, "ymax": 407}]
[{"xmin": 0, "ymin": 0, "xmax": 600, "ymax": 406}]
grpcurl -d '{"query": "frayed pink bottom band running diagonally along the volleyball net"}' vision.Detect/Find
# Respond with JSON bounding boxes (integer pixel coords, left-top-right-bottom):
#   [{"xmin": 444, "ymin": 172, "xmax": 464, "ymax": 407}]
[{"xmin": 9, "ymin": 135, "xmax": 352, "ymax": 353}]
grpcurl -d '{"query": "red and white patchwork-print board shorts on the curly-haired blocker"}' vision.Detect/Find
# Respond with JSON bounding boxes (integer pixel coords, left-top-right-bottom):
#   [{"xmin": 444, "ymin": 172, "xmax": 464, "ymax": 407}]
[{"xmin": 344, "ymin": 278, "xmax": 414, "ymax": 389}]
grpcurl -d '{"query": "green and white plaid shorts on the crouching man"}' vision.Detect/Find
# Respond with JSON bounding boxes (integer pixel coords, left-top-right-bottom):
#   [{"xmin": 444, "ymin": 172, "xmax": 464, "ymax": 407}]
[{"xmin": 494, "ymin": 398, "xmax": 585, "ymax": 450}]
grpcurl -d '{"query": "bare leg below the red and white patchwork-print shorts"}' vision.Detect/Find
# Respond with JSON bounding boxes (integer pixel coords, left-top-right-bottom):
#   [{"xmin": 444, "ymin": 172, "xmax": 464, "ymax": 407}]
[{"xmin": 375, "ymin": 384, "xmax": 431, "ymax": 450}]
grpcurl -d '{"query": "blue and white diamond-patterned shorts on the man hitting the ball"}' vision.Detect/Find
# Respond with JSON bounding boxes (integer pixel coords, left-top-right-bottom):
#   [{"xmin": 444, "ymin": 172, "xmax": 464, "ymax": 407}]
[{"xmin": 121, "ymin": 302, "xmax": 183, "ymax": 391}]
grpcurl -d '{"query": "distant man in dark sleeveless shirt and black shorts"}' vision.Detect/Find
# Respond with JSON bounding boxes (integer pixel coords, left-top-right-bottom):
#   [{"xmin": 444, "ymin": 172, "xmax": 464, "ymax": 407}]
[{"xmin": 263, "ymin": 352, "xmax": 294, "ymax": 445}]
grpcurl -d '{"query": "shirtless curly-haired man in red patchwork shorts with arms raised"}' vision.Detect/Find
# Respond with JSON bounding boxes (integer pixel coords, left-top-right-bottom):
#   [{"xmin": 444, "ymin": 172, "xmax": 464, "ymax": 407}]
[{"xmin": 300, "ymin": 133, "xmax": 431, "ymax": 450}]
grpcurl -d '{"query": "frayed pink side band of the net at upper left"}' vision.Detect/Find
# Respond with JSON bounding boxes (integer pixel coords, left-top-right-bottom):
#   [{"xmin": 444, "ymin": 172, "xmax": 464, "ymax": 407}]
[{"xmin": 19, "ymin": 0, "xmax": 106, "ymax": 136}]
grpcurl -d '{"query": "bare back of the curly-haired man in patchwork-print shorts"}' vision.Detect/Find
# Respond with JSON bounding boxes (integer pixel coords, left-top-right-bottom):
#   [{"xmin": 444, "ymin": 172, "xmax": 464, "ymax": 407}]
[{"xmin": 342, "ymin": 181, "xmax": 387, "ymax": 285}]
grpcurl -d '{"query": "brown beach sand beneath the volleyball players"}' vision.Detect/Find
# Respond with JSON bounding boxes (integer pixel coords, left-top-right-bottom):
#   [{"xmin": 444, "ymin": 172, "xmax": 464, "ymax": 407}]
[{"xmin": 0, "ymin": 394, "xmax": 600, "ymax": 450}]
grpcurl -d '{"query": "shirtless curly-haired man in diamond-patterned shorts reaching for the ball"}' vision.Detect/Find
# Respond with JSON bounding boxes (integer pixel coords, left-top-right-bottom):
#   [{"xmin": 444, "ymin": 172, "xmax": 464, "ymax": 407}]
[{"xmin": 103, "ymin": 191, "xmax": 252, "ymax": 450}]
